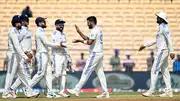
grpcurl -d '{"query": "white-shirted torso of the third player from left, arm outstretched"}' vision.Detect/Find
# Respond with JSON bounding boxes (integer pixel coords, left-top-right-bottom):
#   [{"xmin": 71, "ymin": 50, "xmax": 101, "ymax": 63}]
[{"xmin": 35, "ymin": 27, "xmax": 49, "ymax": 53}]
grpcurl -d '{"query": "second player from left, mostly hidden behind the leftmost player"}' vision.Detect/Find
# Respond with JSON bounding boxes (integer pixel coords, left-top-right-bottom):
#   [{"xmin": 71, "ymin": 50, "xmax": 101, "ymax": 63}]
[{"xmin": 11, "ymin": 15, "xmax": 39, "ymax": 97}]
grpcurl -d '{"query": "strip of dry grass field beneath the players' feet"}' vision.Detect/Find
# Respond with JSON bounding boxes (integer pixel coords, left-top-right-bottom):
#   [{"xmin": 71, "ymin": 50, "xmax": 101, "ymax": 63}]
[{"xmin": 0, "ymin": 92, "xmax": 180, "ymax": 101}]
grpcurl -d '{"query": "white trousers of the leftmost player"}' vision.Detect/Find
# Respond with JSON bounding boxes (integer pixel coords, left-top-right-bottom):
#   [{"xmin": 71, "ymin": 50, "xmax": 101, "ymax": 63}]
[{"xmin": 3, "ymin": 53, "xmax": 30, "ymax": 95}]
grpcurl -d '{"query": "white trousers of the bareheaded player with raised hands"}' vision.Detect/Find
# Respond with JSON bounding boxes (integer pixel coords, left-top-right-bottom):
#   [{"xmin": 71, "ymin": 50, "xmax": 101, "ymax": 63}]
[{"xmin": 74, "ymin": 52, "xmax": 108, "ymax": 92}]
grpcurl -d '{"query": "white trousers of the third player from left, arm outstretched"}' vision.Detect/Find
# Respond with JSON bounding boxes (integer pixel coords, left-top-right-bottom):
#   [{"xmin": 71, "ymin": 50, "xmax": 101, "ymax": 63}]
[{"xmin": 30, "ymin": 53, "xmax": 52, "ymax": 92}]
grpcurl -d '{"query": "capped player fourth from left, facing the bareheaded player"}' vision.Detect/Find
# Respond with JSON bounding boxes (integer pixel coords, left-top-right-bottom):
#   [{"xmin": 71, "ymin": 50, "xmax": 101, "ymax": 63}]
[{"xmin": 51, "ymin": 19, "xmax": 72, "ymax": 97}]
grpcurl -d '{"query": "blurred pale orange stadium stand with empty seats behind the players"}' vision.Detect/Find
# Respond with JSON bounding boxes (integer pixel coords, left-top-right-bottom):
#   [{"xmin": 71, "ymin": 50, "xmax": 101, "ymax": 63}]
[{"xmin": 0, "ymin": 0, "xmax": 180, "ymax": 71}]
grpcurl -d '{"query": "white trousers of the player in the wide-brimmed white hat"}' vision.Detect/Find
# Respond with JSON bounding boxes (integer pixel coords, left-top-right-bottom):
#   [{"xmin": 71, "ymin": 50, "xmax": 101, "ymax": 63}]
[{"xmin": 149, "ymin": 50, "xmax": 171, "ymax": 93}]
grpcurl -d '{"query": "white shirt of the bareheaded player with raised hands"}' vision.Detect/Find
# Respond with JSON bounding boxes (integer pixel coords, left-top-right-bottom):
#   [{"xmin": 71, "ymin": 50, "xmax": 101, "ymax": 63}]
[{"xmin": 89, "ymin": 26, "xmax": 103, "ymax": 52}]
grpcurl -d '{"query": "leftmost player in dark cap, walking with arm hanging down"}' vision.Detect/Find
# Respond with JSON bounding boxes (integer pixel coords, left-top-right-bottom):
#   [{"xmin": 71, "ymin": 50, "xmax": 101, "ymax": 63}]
[{"xmin": 2, "ymin": 15, "xmax": 35, "ymax": 98}]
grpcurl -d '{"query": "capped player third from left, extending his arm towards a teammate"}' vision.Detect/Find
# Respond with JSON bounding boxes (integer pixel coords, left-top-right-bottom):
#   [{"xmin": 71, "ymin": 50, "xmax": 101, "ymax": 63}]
[{"xmin": 30, "ymin": 17, "xmax": 61, "ymax": 98}]
